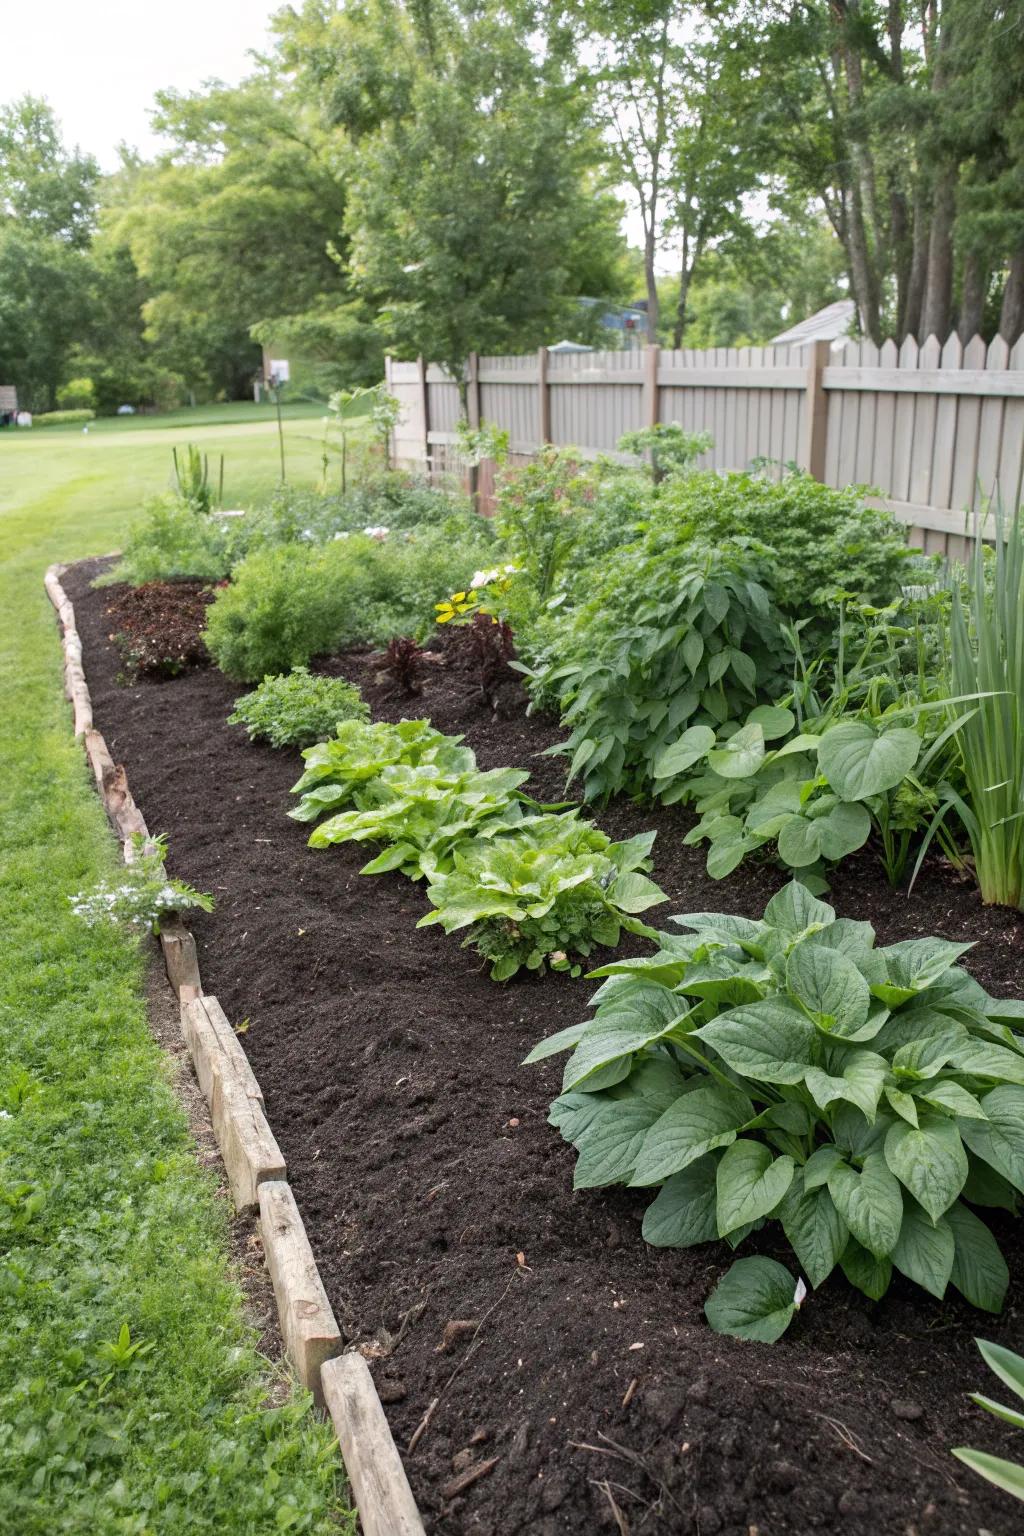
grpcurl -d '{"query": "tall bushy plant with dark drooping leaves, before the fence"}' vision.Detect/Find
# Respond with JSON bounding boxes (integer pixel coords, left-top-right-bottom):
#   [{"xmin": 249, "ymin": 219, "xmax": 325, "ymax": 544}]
[{"xmin": 528, "ymin": 535, "xmax": 781, "ymax": 800}]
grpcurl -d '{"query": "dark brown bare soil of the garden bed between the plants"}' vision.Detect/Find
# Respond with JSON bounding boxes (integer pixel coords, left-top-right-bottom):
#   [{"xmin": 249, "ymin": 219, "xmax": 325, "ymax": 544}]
[{"xmin": 64, "ymin": 565, "xmax": 1024, "ymax": 1536}]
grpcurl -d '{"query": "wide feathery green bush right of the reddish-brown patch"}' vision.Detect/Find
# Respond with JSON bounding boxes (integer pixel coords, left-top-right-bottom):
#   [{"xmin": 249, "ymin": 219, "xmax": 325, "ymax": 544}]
[{"xmin": 206, "ymin": 527, "xmax": 490, "ymax": 682}]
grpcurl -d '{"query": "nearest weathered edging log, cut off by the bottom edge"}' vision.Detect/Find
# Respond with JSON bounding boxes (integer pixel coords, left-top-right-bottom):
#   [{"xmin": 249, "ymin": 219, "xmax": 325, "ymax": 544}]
[{"xmin": 321, "ymin": 1353, "xmax": 424, "ymax": 1536}]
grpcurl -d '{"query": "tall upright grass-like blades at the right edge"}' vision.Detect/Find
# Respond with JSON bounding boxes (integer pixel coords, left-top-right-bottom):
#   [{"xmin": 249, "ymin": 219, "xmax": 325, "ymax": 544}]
[{"xmin": 950, "ymin": 515, "xmax": 1024, "ymax": 906}]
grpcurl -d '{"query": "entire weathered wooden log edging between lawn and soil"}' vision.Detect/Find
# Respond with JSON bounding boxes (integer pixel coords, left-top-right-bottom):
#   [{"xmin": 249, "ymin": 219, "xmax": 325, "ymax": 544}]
[{"xmin": 43, "ymin": 565, "xmax": 425, "ymax": 1536}]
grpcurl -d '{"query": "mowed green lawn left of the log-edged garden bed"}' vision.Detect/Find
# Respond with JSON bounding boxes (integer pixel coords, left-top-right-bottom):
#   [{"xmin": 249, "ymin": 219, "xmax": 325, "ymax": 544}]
[{"xmin": 0, "ymin": 422, "xmax": 352, "ymax": 1536}]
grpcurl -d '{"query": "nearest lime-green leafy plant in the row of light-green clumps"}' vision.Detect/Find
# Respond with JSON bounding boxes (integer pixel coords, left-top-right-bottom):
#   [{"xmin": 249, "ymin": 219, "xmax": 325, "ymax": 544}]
[{"xmin": 419, "ymin": 809, "xmax": 666, "ymax": 982}]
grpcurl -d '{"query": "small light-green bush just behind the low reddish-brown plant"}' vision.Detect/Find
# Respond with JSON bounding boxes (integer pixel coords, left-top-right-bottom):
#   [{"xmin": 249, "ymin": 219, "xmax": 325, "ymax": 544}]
[{"xmin": 100, "ymin": 496, "xmax": 246, "ymax": 587}]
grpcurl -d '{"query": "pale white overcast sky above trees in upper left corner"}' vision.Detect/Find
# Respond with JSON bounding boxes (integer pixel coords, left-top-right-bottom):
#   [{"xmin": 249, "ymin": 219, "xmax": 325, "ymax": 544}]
[{"xmin": 0, "ymin": 0, "xmax": 278, "ymax": 170}]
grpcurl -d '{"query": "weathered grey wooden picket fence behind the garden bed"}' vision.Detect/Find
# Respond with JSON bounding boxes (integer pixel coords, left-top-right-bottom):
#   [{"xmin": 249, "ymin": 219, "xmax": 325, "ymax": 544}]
[{"xmin": 387, "ymin": 335, "xmax": 1024, "ymax": 558}]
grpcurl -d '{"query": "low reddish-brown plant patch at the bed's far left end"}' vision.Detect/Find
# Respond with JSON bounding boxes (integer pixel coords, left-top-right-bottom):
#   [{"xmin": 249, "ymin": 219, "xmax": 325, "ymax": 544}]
[{"xmin": 104, "ymin": 581, "xmax": 215, "ymax": 682}]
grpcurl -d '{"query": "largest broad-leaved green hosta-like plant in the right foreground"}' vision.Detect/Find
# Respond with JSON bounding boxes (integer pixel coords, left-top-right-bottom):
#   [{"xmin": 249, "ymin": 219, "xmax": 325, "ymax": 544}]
[{"xmin": 527, "ymin": 882, "xmax": 1024, "ymax": 1339}]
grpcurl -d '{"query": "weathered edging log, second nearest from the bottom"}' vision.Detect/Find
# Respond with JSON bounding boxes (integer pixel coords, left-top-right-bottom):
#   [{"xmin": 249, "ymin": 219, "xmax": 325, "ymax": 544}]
[{"xmin": 259, "ymin": 1180, "xmax": 342, "ymax": 1407}]
